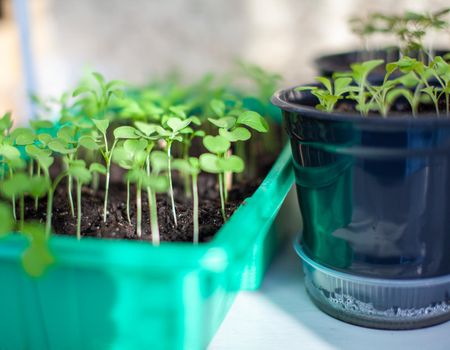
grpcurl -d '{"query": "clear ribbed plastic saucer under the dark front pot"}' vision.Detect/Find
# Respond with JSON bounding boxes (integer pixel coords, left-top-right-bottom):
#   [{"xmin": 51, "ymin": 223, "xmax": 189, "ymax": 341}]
[{"xmin": 294, "ymin": 239, "xmax": 450, "ymax": 330}]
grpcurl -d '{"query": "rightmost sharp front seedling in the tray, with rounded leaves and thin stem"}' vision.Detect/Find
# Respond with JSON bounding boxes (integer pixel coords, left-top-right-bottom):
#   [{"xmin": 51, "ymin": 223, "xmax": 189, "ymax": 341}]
[{"xmin": 199, "ymin": 135, "xmax": 244, "ymax": 221}]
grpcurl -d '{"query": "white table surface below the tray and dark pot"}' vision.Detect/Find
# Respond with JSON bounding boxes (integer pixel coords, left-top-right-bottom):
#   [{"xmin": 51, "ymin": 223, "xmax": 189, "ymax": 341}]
[{"xmin": 209, "ymin": 242, "xmax": 450, "ymax": 350}]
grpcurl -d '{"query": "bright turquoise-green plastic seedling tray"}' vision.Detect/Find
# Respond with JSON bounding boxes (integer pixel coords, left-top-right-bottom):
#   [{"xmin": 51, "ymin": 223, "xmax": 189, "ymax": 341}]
[{"xmin": 0, "ymin": 147, "xmax": 294, "ymax": 350}]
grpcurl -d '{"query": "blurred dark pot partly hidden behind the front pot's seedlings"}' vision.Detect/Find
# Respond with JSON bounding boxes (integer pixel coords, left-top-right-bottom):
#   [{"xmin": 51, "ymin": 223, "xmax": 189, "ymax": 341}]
[{"xmin": 314, "ymin": 47, "xmax": 449, "ymax": 82}]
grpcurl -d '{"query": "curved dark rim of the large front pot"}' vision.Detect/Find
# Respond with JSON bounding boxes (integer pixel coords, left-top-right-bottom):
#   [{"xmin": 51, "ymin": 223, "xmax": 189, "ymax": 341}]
[{"xmin": 270, "ymin": 84, "xmax": 450, "ymax": 128}]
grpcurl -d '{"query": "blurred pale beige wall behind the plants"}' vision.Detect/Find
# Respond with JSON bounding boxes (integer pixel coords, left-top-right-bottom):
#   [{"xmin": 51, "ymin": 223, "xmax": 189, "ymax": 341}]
[{"xmin": 0, "ymin": 0, "xmax": 450, "ymax": 121}]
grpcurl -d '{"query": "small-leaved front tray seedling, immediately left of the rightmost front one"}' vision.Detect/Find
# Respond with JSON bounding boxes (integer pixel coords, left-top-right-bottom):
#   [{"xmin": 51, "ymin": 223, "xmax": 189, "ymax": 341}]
[{"xmin": 173, "ymin": 157, "xmax": 201, "ymax": 244}]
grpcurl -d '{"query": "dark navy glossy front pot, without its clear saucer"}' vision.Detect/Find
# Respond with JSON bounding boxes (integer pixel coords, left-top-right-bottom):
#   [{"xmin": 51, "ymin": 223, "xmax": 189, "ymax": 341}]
[{"xmin": 272, "ymin": 89, "xmax": 450, "ymax": 279}]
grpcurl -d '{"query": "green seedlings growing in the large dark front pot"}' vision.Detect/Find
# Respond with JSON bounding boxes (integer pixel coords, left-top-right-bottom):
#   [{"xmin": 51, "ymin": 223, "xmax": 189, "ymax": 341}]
[{"xmin": 306, "ymin": 56, "xmax": 450, "ymax": 117}]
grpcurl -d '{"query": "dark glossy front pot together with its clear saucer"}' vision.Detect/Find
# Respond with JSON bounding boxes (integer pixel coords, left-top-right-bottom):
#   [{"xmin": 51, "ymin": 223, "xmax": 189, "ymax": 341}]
[{"xmin": 272, "ymin": 89, "xmax": 450, "ymax": 329}]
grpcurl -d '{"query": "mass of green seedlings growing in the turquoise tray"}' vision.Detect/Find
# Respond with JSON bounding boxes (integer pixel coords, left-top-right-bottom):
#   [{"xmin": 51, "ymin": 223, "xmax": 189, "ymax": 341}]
[{"xmin": 0, "ymin": 64, "xmax": 279, "ymax": 246}]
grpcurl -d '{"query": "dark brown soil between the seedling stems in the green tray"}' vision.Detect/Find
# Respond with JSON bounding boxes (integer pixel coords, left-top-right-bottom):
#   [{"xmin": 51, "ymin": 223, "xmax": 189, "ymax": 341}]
[{"xmin": 25, "ymin": 159, "xmax": 274, "ymax": 242}]
